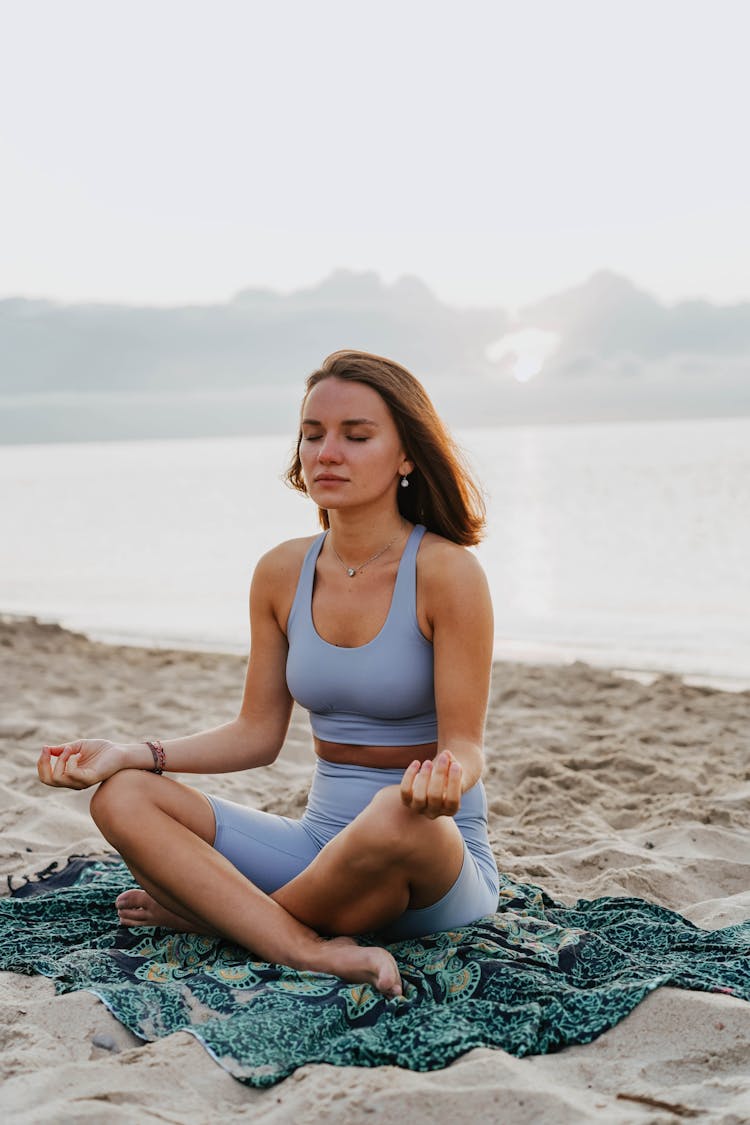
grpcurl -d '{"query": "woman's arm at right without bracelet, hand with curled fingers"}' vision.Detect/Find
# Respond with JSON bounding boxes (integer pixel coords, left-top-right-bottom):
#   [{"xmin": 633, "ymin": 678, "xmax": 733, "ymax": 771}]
[{"xmin": 401, "ymin": 541, "xmax": 494, "ymax": 817}]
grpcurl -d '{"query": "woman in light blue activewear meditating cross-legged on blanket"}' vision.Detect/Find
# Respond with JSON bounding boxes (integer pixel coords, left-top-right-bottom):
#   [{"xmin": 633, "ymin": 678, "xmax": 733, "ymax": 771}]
[{"xmin": 38, "ymin": 351, "xmax": 498, "ymax": 996}]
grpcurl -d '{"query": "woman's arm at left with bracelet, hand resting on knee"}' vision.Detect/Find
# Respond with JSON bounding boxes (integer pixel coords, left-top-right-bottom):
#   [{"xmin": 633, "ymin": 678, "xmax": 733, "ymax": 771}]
[{"xmin": 37, "ymin": 543, "xmax": 295, "ymax": 789}]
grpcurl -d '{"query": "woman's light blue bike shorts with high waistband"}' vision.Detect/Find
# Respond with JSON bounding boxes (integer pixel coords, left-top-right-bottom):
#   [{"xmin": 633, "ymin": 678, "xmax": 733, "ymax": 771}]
[{"xmin": 207, "ymin": 758, "xmax": 498, "ymax": 942}]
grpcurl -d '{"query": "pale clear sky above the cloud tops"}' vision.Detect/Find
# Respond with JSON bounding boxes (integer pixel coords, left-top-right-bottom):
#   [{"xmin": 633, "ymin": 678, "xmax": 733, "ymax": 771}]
[{"xmin": 0, "ymin": 0, "xmax": 750, "ymax": 308}]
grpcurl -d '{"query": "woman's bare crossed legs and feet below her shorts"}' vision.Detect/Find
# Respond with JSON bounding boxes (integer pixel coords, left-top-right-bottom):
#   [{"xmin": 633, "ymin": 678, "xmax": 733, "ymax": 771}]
[{"xmin": 91, "ymin": 770, "xmax": 463, "ymax": 996}]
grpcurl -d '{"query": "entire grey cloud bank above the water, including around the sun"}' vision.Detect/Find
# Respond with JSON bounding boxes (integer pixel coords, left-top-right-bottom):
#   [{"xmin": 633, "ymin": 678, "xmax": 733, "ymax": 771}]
[{"xmin": 0, "ymin": 270, "xmax": 750, "ymax": 441}]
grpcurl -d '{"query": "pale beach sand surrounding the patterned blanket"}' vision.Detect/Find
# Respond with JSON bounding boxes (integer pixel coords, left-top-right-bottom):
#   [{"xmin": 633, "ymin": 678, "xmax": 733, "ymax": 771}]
[{"xmin": 0, "ymin": 619, "xmax": 750, "ymax": 1125}]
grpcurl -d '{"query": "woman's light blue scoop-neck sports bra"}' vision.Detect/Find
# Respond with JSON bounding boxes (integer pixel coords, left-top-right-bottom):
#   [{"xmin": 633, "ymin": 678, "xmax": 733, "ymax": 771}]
[{"xmin": 287, "ymin": 524, "xmax": 437, "ymax": 746}]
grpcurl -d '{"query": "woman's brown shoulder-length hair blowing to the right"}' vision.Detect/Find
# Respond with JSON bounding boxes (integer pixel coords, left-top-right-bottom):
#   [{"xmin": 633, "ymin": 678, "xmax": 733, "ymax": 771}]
[{"xmin": 284, "ymin": 351, "xmax": 486, "ymax": 547}]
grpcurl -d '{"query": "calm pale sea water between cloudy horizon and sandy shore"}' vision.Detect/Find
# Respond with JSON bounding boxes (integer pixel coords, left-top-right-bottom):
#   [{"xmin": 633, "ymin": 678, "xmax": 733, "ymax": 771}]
[{"xmin": 0, "ymin": 419, "xmax": 750, "ymax": 681}]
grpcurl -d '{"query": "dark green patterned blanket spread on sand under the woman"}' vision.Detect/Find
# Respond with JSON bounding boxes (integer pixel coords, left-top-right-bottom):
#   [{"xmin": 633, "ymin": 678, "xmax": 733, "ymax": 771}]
[{"xmin": 0, "ymin": 857, "xmax": 750, "ymax": 1087}]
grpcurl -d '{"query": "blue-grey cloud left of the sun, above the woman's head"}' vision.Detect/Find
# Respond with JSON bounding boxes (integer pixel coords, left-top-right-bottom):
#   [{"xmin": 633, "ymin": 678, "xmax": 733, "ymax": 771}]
[{"xmin": 0, "ymin": 270, "xmax": 507, "ymax": 394}]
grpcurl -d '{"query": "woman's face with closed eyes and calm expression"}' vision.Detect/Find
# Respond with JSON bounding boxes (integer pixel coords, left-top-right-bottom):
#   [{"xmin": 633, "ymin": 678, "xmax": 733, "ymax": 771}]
[{"xmin": 299, "ymin": 376, "xmax": 414, "ymax": 510}]
